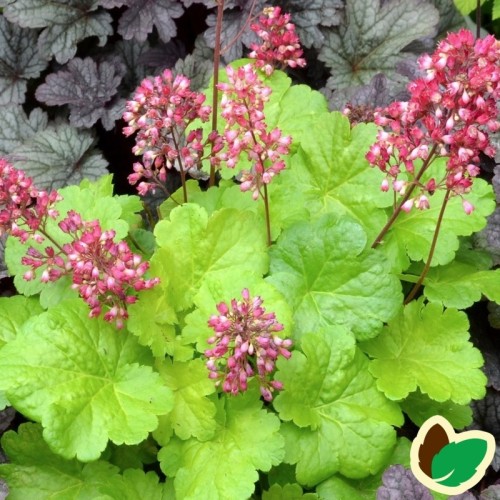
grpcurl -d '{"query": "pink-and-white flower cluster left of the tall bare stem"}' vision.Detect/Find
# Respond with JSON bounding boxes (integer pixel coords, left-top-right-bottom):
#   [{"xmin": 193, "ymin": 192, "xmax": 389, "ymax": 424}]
[{"xmin": 123, "ymin": 69, "xmax": 218, "ymax": 195}]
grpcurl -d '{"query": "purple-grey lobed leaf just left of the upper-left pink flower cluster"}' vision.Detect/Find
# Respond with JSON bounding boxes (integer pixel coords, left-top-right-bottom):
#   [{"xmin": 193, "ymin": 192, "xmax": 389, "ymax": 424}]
[{"xmin": 35, "ymin": 57, "xmax": 125, "ymax": 130}]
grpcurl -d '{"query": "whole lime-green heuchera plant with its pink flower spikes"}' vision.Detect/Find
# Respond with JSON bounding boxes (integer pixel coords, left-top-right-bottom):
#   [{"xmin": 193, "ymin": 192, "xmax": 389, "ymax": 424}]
[{"xmin": 0, "ymin": 2, "xmax": 500, "ymax": 499}]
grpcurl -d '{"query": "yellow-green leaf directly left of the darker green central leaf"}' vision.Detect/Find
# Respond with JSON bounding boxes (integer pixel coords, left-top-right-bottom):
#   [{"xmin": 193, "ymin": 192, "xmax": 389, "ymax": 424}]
[{"xmin": 151, "ymin": 203, "xmax": 268, "ymax": 311}]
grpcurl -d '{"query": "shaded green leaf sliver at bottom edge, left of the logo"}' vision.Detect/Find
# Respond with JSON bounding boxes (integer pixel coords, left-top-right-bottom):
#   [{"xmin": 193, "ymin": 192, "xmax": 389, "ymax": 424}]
[{"xmin": 316, "ymin": 437, "xmax": 411, "ymax": 500}]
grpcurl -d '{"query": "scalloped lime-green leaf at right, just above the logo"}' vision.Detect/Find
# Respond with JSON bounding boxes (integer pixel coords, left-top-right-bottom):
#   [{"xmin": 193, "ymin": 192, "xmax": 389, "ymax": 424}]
[{"xmin": 361, "ymin": 298, "xmax": 486, "ymax": 405}]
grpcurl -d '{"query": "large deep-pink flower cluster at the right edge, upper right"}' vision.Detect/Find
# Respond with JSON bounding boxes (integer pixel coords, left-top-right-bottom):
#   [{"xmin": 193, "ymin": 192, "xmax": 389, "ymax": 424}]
[{"xmin": 366, "ymin": 29, "xmax": 500, "ymax": 213}]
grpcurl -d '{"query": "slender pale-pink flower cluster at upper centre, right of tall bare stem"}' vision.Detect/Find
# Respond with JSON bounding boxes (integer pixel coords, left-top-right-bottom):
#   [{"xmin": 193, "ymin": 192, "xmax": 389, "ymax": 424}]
[{"xmin": 218, "ymin": 64, "xmax": 292, "ymax": 200}]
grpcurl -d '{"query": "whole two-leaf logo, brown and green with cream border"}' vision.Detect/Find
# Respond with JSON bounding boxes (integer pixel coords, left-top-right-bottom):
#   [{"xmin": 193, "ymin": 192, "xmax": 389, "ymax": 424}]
[{"xmin": 410, "ymin": 415, "xmax": 495, "ymax": 495}]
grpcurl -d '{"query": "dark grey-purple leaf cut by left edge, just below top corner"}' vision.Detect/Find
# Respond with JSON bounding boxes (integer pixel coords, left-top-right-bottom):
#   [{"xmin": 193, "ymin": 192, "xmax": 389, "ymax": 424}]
[{"xmin": 0, "ymin": 15, "xmax": 48, "ymax": 105}]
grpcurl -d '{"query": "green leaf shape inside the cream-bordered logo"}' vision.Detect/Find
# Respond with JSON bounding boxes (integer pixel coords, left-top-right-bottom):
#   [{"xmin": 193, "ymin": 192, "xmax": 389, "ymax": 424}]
[{"xmin": 431, "ymin": 438, "xmax": 488, "ymax": 487}]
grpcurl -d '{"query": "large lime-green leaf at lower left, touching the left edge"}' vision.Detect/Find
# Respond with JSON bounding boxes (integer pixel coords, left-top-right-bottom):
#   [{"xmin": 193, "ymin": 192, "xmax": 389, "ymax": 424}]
[{"xmin": 0, "ymin": 299, "xmax": 173, "ymax": 461}]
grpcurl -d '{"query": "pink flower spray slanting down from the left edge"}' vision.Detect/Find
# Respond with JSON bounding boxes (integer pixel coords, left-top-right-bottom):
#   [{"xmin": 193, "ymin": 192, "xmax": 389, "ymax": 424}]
[{"xmin": 0, "ymin": 159, "xmax": 159, "ymax": 328}]
